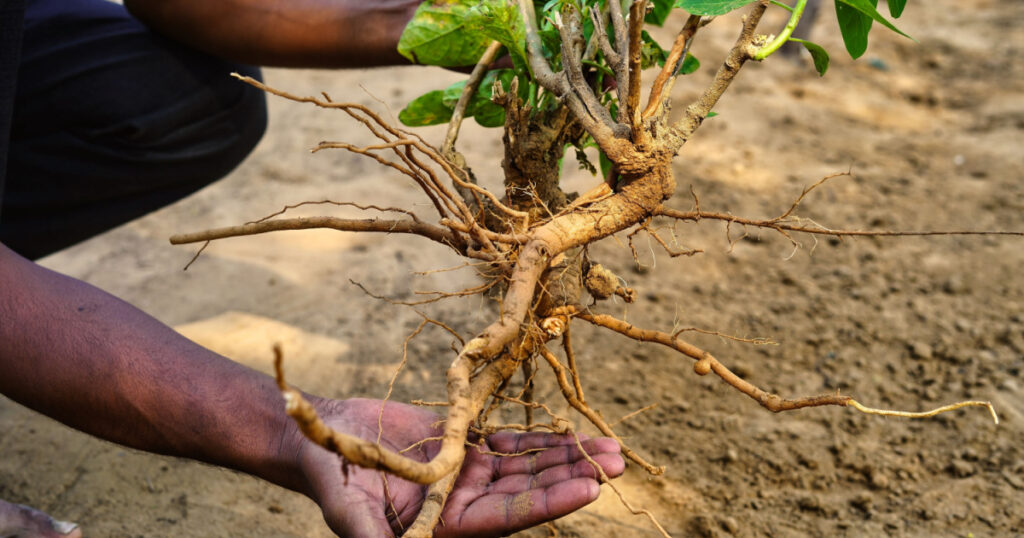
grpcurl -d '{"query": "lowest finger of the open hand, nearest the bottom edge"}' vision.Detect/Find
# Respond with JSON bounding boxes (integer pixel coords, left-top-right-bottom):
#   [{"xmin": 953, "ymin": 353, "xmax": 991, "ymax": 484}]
[{"xmin": 436, "ymin": 475, "xmax": 600, "ymax": 536}]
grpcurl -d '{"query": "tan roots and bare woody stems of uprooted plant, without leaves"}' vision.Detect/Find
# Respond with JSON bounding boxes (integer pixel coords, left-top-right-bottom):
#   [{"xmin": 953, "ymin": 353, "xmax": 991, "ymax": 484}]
[{"xmin": 171, "ymin": 0, "xmax": 1007, "ymax": 536}]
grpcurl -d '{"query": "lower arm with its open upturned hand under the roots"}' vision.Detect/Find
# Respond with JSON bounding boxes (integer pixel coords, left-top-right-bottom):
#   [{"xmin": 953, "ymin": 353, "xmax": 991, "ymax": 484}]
[{"xmin": 0, "ymin": 240, "xmax": 625, "ymax": 537}]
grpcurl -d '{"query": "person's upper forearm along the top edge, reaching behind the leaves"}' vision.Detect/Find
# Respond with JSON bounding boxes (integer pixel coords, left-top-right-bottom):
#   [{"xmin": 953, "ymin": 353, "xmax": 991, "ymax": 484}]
[{"xmin": 125, "ymin": 0, "xmax": 419, "ymax": 68}]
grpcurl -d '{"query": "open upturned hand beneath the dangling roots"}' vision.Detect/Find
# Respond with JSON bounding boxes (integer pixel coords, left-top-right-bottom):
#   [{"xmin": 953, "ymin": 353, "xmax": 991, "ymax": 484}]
[{"xmin": 299, "ymin": 399, "xmax": 626, "ymax": 538}]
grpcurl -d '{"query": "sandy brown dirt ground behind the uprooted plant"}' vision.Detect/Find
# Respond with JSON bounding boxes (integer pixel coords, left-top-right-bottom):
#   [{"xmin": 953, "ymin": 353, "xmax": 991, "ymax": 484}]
[{"xmin": 0, "ymin": 0, "xmax": 1024, "ymax": 537}]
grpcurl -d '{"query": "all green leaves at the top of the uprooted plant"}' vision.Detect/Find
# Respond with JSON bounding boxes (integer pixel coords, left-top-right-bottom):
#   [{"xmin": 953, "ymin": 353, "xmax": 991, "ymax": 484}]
[{"xmin": 398, "ymin": 0, "xmax": 909, "ymax": 160}]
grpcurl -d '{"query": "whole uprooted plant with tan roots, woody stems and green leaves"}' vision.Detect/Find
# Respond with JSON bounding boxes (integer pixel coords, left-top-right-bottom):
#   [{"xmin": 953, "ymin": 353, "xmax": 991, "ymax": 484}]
[{"xmin": 171, "ymin": 0, "xmax": 1022, "ymax": 536}]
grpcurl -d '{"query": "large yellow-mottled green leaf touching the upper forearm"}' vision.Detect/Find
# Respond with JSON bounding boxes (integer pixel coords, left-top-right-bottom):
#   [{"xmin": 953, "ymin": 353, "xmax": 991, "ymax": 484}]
[{"xmin": 398, "ymin": 0, "xmax": 490, "ymax": 68}]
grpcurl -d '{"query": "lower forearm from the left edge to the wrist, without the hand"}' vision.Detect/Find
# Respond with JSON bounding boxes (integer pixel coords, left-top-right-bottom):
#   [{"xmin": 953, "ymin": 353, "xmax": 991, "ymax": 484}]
[{"xmin": 0, "ymin": 245, "xmax": 308, "ymax": 493}]
